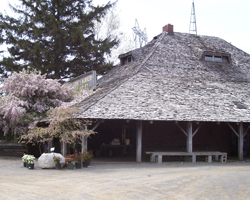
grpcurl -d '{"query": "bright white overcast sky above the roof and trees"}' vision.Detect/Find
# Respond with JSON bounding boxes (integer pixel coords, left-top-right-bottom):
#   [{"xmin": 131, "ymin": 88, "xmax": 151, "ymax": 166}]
[{"xmin": 0, "ymin": 0, "xmax": 250, "ymax": 54}]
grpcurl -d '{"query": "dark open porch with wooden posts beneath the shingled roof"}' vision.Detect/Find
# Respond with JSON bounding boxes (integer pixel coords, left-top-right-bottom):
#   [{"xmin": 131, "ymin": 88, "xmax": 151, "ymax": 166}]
[{"xmin": 85, "ymin": 119, "xmax": 250, "ymax": 162}]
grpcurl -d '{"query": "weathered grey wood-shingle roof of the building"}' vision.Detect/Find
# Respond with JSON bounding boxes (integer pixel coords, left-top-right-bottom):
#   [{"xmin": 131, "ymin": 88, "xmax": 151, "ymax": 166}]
[{"xmin": 73, "ymin": 32, "xmax": 250, "ymax": 122}]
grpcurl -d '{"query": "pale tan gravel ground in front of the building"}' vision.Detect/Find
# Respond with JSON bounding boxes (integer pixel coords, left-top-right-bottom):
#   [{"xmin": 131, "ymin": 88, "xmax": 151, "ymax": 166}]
[{"xmin": 0, "ymin": 157, "xmax": 250, "ymax": 200}]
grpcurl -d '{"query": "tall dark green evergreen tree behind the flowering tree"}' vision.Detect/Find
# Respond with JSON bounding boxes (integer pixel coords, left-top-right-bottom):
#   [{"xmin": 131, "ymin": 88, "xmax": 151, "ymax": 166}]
[{"xmin": 0, "ymin": 0, "xmax": 118, "ymax": 79}]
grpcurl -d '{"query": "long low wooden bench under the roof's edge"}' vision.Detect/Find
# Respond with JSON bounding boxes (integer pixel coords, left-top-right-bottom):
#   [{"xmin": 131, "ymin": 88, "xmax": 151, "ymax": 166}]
[{"xmin": 146, "ymin": 151, "xmax": 227, "ymax": 163}]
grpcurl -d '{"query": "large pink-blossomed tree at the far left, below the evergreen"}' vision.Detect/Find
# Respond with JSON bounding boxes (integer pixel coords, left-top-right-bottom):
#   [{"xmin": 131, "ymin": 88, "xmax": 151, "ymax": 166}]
[{"xmin": 0, "ymin": 69, "xmax": 73, "ymax": 135}]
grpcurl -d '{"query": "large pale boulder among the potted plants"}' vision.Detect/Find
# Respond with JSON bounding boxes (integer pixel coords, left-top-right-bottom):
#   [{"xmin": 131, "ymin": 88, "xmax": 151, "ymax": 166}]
[{"xmin": 38, "ymin": 153, "xmax": 65, "ymax": 169}]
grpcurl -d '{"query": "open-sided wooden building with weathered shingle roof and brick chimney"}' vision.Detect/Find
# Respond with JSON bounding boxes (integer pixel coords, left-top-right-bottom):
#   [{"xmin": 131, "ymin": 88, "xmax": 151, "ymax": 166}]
[{"xmin": 72, "ymin": 24, "xmax": 250, "ymax": 162}]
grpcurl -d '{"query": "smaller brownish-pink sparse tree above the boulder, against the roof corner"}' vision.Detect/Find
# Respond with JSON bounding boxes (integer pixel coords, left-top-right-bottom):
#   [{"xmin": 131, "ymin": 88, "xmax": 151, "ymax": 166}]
[{"xmin": 20, "ymin": 84, "xmax": 95, "ymax": 146}]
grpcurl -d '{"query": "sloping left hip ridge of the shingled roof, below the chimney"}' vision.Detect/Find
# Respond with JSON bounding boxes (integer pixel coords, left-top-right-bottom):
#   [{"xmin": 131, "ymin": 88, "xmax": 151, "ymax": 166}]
[{"xmin": 79, "ymin": 32, "xmax": 166, "ymax": 112}]
